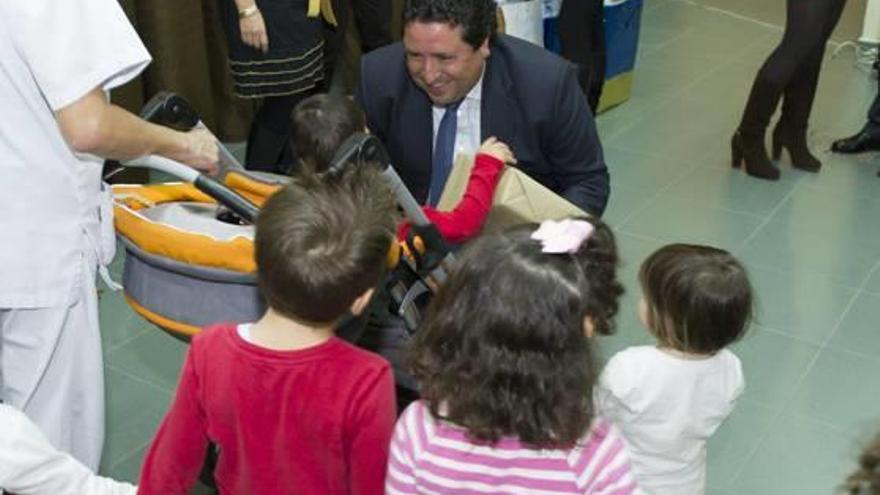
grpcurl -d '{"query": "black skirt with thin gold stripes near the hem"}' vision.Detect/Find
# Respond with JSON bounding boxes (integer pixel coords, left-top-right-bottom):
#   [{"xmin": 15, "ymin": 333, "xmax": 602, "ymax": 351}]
[{"xmin": 219, "ymin": 0, "xmax": 324, "ymax": 98}]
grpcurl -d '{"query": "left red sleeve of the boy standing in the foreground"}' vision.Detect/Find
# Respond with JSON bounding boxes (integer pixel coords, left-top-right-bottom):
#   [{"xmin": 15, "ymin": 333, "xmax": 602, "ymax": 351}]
[{"xmin": 138, "ymin": 342, "xmax": 208, "ymax": 495}]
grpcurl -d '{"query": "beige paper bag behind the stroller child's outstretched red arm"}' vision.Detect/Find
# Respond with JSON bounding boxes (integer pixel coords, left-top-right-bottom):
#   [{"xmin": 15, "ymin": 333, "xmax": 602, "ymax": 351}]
[{"xmin": 437, "ymin": 155, "xmax": 587, "ymax": 232}]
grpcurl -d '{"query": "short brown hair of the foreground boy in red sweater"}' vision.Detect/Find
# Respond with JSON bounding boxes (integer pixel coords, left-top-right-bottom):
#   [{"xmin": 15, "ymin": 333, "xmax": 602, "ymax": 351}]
[{"xmin": 254, "ymin": 164, "xmax": 395, "ymax": 323}]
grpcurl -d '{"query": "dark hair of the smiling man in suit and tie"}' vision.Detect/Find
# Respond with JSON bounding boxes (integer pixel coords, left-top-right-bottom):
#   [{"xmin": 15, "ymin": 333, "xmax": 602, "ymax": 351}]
[{"xmin": 403, "ymin": 0, "xmax": 498, "ymax": 50}]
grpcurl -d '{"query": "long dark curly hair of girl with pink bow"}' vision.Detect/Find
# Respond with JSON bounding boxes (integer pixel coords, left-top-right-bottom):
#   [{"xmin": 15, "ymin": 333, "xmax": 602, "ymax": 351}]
[{"xmin": 408, "ymin": 219, "xmax": 623, "ymax": 448}]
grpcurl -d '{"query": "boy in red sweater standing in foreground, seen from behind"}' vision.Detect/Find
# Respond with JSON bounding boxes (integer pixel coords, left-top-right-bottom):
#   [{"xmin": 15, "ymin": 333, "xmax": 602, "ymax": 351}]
[{"xmin": 139, "ymin": 167, "xmax": 396, "ymax": 495}]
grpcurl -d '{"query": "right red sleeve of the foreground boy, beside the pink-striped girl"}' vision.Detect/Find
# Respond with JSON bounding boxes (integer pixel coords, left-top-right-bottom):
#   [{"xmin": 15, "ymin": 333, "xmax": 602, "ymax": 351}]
[{"xmin": 346, "ymin": 363, "xmax": 397, "ymax": 495}]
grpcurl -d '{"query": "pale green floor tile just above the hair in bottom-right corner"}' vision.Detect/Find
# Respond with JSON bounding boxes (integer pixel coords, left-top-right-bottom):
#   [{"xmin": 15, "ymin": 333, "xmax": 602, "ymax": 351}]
[{"xmin": 791, "ymin": 348, "xmax": 880, "ymax": 430}]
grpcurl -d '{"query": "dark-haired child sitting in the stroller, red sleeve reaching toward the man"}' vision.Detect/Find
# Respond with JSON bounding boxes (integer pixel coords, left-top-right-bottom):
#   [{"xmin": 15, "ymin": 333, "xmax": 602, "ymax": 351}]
[{"xmin": 291, "ymin": 94, "xmax": 516, "ymax": 244}]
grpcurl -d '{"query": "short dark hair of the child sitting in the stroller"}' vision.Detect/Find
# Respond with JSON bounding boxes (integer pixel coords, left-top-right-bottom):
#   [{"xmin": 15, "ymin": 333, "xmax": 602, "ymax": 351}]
[{"xmin": 290, "ymin": 94, "xmax": 366, "ymax": 173}]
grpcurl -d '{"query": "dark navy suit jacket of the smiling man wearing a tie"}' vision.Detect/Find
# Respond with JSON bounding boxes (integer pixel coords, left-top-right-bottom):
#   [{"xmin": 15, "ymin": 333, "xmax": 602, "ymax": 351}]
[{"xmin": 357, "ymin": 35, "xmax": 609, "ymax": 215}]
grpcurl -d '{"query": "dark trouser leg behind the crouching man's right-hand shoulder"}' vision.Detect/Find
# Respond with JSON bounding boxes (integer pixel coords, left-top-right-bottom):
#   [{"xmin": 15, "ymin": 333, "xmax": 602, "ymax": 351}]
[{"xmin": 559, "ymin": 0, "xmax": 605, "ymax": 114}]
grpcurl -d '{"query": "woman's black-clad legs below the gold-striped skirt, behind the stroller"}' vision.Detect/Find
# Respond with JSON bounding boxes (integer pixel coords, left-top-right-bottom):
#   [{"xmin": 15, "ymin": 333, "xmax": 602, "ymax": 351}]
[{"xmin": 245, "ymin": 91, "xmax": 312, "ymax": 173}]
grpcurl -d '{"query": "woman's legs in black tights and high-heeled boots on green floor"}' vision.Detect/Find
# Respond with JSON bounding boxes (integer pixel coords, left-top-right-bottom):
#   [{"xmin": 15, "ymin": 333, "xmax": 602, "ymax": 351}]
[{"xmin": 734, "ymin": 0, "xmax": 845, "ymax": 179}]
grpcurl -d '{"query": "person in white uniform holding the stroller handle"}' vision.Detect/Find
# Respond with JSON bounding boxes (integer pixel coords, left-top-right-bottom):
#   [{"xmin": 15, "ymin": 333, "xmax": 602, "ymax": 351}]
[{"xmin": 0, "ymin": 0, "xmax": 217, "ymax": 470}]
